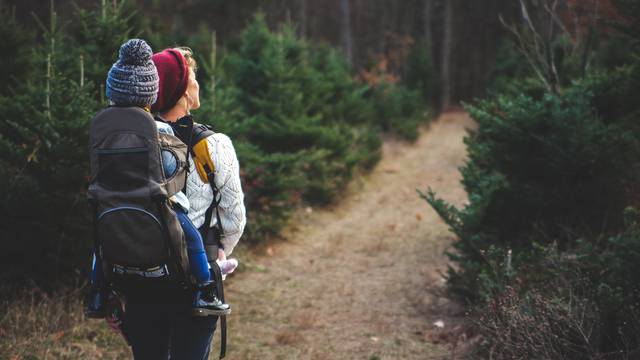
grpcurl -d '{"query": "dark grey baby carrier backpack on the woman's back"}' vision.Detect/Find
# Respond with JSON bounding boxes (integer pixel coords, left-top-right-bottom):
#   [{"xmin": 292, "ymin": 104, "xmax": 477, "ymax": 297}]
[{"xmin": 87, "ymin": 107, "xmax": 189, "ymax": 286}]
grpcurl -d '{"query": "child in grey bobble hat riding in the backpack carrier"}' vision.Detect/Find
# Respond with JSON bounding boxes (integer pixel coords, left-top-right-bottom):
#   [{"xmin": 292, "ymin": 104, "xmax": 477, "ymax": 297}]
[{"xmin": 85, "ymin": 39, "xmax": 237, "ymax": 318}]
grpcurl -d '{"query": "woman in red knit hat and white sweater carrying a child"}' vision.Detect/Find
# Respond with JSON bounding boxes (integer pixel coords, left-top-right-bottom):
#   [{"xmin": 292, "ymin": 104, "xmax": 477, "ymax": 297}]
[{"xmin": 123, "ymin": 48, "xmax": 246, "ymax": 360}]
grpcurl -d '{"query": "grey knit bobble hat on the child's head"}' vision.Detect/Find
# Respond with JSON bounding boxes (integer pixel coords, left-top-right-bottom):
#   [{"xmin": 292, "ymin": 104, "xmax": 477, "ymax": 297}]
[{"xmin": 106, "ymin": 39, "xmax": 159, "ymax": 106}]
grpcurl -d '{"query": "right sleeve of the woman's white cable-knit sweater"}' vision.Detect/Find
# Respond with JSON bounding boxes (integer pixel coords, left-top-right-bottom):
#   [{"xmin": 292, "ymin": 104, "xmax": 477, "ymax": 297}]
[{"xmin": 207, "ymin": 133, "xmax": 247, "ymax": 256}]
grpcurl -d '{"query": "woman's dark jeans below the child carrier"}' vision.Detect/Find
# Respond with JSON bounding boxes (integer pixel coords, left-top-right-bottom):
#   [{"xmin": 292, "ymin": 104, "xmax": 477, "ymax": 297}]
[{"xmin": 123, "ymin": 280, "xmax": 218, "ymax": 360}]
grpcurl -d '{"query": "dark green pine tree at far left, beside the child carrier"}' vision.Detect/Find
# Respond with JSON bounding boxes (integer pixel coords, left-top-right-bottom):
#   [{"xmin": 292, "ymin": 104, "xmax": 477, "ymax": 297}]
[{"xmin": 0, "ymin": 2, "xmax": 135, "ymax": 280}]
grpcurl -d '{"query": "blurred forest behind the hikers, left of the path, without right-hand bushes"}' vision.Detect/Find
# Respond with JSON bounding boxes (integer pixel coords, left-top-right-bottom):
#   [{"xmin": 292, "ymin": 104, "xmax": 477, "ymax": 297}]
[{"xmin": 0, "ymin": 0, "xmax": 517, "ymax": 286}]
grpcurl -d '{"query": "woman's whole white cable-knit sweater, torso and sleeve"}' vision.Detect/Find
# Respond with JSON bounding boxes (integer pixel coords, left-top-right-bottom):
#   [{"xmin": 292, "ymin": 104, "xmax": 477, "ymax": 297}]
[{"xmin": 187, "ymin": 133, "xmax": 247, "ymax": 256}]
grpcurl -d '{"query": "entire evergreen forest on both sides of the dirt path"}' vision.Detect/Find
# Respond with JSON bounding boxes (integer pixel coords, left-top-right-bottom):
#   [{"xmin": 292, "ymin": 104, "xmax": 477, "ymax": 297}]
[{"xmin": 0, "ymin": 0, "xmax": 640, "ymax": 359}]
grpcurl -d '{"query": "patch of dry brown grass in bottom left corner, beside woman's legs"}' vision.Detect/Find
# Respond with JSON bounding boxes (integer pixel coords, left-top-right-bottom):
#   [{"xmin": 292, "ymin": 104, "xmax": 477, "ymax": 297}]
[{"xmin": 0, "ymin": 288, "xmax": 129, "ymax": 360}]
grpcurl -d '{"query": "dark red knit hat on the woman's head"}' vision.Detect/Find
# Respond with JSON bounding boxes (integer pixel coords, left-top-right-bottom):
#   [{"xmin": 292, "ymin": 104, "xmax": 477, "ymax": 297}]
[{"xmin": 151, "ymin": 49, "xmax": 189, "ymax": 112}]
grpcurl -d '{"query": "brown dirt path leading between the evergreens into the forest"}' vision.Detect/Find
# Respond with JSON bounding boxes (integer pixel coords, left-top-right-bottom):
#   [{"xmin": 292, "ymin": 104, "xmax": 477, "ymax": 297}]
[{"xmin": 224, "ymin": 114, "xmax": 471, "ymax": 360}]
